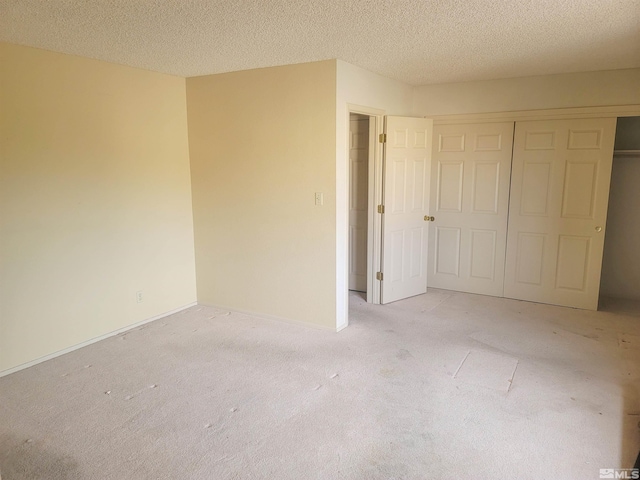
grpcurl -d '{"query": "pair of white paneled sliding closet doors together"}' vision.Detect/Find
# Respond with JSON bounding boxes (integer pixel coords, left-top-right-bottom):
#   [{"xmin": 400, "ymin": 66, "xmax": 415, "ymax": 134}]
[{"xmin": 429, "ymin": 118, "xmax": 616, "ymax": 309}]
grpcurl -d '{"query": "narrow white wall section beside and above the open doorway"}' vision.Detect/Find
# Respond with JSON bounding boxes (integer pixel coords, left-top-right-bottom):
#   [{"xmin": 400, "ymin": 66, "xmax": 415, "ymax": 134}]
[{"xmin": 336, "ymin": 60, "xmax": 413, "ymax": 329}]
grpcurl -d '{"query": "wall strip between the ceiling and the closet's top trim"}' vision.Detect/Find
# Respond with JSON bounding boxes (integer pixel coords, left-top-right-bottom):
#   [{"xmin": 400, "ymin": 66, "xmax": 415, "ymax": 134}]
[{"xmin": 414, "ymin": 68, "xmax": 640, "ymax": 116}]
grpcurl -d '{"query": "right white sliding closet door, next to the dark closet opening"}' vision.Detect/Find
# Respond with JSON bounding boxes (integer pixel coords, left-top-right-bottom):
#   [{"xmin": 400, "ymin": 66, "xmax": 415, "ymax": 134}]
[{"xmin": 504, "ymin": 118, "xmax": 616, "ymax": 310}]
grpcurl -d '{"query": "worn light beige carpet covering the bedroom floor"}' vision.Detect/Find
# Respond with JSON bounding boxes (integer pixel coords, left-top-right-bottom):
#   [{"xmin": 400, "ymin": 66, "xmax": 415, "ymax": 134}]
[{"xmin": 0, "ymin": 290, "xmax": 640, "ymax": 480}]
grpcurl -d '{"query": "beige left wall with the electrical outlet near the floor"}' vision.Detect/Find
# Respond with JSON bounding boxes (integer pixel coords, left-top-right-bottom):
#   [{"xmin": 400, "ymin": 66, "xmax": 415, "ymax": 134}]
[{"xmin": 0, "ymin": 44, "xmax": 195, "ymax": 371}]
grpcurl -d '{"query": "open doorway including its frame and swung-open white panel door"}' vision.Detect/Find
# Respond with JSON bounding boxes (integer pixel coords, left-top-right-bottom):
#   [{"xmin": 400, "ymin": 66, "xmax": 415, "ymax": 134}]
[{"xmin": 345, "ymin": 109, "xmax": 433, "ymax": 304}]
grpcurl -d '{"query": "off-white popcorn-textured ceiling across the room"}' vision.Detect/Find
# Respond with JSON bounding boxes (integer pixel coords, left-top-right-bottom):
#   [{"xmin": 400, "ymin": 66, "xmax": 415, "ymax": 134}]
[{"xmin": 0, "ymin": 0, "xmax": 640, "ymax": 88}]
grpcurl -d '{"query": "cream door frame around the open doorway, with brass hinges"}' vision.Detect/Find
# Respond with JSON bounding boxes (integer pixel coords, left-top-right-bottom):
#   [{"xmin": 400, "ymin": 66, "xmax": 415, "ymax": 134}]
[{"xmin": 346, "ymin": 104, "xmax": 385, "ymax": 304}]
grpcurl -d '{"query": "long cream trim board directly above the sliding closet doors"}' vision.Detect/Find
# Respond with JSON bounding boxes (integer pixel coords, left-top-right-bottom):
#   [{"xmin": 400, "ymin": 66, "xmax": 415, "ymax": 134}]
[{"xmin": 427, "ymin": 105, "xmax": 640, "ymax": 125}]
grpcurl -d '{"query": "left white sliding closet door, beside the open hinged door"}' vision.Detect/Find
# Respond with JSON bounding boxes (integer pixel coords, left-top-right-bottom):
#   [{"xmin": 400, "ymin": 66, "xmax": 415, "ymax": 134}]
[{"xmin": 428, "ymin": 122, "xmax": 513, "ymax": 296}]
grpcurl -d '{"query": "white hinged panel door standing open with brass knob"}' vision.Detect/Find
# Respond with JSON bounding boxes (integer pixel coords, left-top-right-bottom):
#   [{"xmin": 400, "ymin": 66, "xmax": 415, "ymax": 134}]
[{"xmin": 381, "ymin": 117, "xmax": 433, "ymax": 303}]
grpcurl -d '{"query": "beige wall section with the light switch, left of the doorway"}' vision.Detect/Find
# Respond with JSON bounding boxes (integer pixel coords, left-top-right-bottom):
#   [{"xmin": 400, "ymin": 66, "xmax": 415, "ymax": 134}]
[{"xmin": 187, "ymin": 61, "xmax": 336, "ymax": 329}]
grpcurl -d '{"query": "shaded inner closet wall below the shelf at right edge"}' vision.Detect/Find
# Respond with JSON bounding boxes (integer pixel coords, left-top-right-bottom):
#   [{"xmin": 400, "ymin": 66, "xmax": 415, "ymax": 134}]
[{"xmin": 600, "ymin": 154, "xmax": 640, "ymax": 300}]
